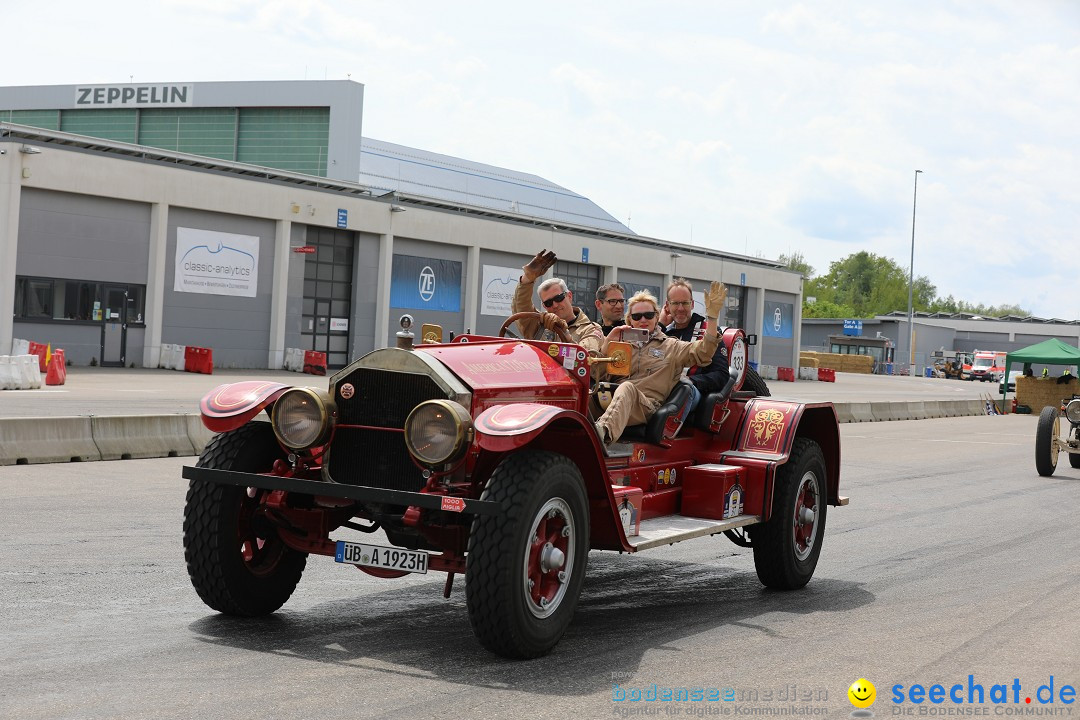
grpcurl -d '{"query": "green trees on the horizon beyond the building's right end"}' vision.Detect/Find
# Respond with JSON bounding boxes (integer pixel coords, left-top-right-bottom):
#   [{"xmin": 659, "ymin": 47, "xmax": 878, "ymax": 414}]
[{"xmin": 780, "ymin": 250, "xmax": 1031, "ymax": 318}]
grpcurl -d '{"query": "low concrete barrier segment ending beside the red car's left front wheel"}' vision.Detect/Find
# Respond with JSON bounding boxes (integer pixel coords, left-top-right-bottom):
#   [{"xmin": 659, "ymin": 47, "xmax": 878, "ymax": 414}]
[{"xmin": 91, "ymin": 415, "xmax": 195, "ymax": 460}]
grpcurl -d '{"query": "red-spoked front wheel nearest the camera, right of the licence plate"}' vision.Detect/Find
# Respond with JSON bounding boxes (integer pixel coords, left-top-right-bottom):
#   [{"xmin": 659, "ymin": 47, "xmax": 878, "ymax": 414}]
[{"xmin": 465, "ymin": 451, "xmax": 589, "ymax": 657}]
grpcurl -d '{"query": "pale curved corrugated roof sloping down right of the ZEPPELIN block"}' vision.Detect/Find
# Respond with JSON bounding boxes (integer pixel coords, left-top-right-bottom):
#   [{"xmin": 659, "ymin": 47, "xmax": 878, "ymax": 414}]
[{"xmin": 359, "ymin": 137, "xmax": 635, "ymax": 235}]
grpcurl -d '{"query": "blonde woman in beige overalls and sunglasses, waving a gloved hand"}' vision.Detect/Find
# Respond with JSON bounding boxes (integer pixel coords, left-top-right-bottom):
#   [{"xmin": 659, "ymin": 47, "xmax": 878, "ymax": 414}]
[{"xmin": 596, "ymin": 282, "xmax": 728, "ymax": 445}]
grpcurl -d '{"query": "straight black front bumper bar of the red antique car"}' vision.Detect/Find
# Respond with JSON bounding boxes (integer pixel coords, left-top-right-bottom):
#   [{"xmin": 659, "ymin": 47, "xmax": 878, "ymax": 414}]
[{"xmin": 181, "ymin": 465, "xmax": 503, "ymax": 515}]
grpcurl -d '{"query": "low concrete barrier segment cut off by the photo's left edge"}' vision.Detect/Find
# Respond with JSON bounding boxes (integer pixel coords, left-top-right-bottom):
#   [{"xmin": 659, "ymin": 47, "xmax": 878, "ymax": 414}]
[{"xmin": 0, "ymin": 418, "xmax": 102, "ymax": 465}]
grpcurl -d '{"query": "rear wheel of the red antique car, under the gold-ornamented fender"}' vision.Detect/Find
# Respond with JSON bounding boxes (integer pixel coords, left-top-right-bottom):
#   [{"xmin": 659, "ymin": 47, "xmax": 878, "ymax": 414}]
[{"xmin": 750, "ymin": 437, "xmax": 827, "ymax": 590}]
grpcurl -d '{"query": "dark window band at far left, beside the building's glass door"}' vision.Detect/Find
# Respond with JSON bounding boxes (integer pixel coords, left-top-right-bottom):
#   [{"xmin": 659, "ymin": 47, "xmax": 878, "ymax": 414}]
[{"xmin": 14, "ymin": 277, "xmax": 146, "ymax": 325}]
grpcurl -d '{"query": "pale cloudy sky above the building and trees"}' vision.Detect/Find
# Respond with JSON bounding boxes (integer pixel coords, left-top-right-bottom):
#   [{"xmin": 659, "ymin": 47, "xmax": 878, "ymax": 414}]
[{"xmin": 10, "ymin": 0, "xmax": 1080, "ymax": 320}]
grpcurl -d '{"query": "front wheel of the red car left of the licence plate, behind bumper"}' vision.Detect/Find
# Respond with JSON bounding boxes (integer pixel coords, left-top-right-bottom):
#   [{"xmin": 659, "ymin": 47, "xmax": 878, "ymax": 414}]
[{"xmin": 184, "ymin": 422, "xmax": 308, "ymax": 616}]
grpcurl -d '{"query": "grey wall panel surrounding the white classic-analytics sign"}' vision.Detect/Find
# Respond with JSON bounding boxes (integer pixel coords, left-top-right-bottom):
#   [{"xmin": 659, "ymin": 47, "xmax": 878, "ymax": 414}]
[{"xmin": 163, "ymin": 207, "xmax": 274, "ymax": 368}]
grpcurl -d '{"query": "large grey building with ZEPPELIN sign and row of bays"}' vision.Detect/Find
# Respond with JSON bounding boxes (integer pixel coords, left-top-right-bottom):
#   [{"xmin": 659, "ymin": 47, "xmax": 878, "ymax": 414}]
[{"xmin": 0, "ymin": 81, "xmax": 802, "ymax": 368}]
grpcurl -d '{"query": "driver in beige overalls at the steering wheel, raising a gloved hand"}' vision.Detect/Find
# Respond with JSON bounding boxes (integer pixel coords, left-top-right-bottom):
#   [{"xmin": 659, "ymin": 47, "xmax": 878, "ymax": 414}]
[{"xmin": 511, "ymin": 249, "xmax": 604, "ymax": 353}]
